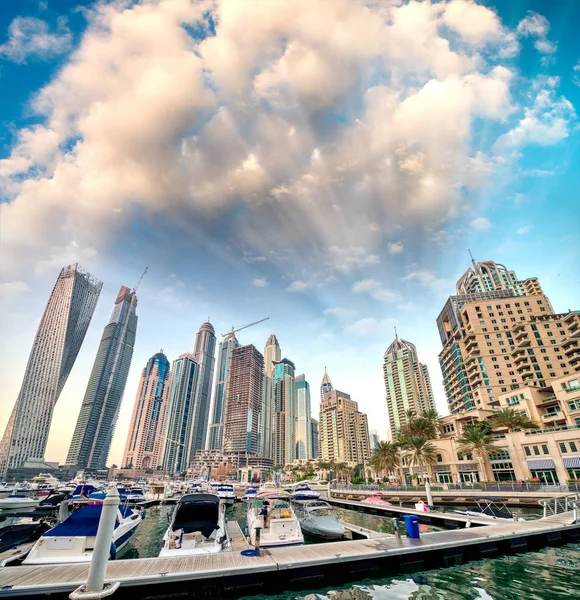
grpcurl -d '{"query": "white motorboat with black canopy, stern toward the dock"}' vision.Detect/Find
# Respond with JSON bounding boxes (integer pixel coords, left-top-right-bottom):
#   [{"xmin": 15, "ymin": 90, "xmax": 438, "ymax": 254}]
[{"xmin": 159, "ymin": 494, "xmax": 232, "ymax": 556}]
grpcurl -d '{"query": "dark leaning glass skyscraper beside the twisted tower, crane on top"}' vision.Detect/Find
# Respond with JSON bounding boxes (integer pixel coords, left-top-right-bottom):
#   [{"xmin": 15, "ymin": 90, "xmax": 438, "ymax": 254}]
[{"xmin": 66, "ymin": 285, "xmax": 137, "ymax": 469}]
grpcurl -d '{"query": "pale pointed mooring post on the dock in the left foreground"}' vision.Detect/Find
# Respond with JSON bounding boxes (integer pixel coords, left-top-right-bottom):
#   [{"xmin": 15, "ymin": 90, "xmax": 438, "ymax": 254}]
[{"xmin": 69, "ymin": 483, "xmax": 120, "ymax": 600}]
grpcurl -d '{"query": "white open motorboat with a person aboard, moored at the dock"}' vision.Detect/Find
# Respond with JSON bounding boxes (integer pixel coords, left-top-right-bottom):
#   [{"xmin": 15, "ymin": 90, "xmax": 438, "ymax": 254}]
[{"xmin": 246, "ymin": 492, "xmax": 304, "ymax": 548}]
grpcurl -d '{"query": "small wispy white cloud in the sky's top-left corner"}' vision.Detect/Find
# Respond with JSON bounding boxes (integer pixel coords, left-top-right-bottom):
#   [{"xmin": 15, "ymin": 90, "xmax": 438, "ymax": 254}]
[{"xmin": 0, "ymin": 17, "xmax": 72, "ymax": 63}]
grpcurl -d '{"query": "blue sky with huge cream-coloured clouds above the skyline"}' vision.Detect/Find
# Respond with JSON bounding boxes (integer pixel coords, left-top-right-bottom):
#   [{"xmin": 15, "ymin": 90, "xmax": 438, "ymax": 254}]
[{"xmin": 0, "ymin": 0, "xmax": 580, "ymax": 464}]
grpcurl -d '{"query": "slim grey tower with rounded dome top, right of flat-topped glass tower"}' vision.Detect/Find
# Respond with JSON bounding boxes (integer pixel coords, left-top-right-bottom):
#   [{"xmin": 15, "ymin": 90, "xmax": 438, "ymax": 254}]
[{"xmin": 191, "ymin": 322, "xmax": 216, "ymax": 459}]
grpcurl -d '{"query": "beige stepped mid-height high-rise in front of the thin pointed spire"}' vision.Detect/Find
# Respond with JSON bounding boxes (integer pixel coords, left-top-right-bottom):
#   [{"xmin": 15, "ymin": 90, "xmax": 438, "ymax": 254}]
[{"xmin": 318, "ymin": 390, "xmax": 371, "ymax": 465}]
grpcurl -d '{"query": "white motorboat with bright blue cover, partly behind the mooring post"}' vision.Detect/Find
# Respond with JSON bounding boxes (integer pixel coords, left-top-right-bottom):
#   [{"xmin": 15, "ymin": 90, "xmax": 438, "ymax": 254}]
[{"xmin": 23, "ymin": 504, "xmax": 142, "ymax": 565}]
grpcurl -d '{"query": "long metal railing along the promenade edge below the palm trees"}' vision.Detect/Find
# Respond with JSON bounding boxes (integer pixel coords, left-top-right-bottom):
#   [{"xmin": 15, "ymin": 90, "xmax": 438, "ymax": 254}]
[{"xmin": 331, "ymin": 481, "xmax": 580, "ymax": 493}]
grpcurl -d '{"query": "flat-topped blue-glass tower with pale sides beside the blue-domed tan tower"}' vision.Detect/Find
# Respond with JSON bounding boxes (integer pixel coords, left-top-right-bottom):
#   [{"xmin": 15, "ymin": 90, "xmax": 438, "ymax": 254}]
[{"xmin": 161, "ymin": 354, "xmax": 199, "ymax": 473}]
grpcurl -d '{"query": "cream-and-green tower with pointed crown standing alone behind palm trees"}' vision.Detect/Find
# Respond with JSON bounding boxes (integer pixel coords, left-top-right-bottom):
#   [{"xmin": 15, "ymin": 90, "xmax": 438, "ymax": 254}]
[{"xmin": 383, "ymin": 336, "xmax": 435, "ymax": 434}]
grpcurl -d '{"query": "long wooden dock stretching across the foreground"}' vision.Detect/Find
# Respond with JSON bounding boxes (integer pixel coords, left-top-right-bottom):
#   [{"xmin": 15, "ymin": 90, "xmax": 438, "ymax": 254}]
[{"xmin": 0, "ymin": 512, "xmax": 580, "ymax": 599}]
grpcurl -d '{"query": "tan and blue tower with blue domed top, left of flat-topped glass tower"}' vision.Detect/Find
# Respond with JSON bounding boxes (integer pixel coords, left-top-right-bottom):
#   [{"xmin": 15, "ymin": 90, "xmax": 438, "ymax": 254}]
[{"xmin": 122, "ymin": 351, "xmax": 169, "ymax": 469}]
